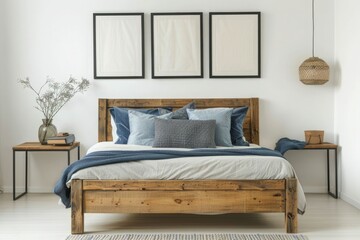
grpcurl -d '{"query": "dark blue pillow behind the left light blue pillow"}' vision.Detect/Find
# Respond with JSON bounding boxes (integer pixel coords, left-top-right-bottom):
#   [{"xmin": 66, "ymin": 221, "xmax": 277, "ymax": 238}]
[{"xmin": 110, "ymin": 107, "xmax": 171, "ymax": 144}]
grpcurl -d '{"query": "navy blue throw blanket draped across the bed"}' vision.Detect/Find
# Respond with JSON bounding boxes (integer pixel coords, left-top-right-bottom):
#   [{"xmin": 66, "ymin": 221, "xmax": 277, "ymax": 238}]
[{"xmin": 54, "ymin": 148, "xmax": 282, "ymax": 207}]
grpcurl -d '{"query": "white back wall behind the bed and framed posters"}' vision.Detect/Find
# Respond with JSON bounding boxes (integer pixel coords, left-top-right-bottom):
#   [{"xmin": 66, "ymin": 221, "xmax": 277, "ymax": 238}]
[{"xmin": 0, "ymin": 0, "xmax": 334, "ymax": 191}]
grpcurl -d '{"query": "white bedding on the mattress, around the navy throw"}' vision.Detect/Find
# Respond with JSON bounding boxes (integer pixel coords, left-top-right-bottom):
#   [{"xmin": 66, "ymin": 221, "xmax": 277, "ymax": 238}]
[{"xmin": 68, "ymin": 142, "xmax": 306, "ymax": 212}]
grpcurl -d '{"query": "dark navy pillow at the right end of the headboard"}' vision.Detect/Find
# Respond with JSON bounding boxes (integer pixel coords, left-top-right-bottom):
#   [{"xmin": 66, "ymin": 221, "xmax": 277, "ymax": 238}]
[{"xmin": 230, "ymin": 107, "xmax": 249, "ymax": 146}]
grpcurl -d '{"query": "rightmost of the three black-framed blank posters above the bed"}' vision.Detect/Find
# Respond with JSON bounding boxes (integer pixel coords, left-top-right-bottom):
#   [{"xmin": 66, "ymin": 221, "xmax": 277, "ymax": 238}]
[{"xmin": 209, "ymin": 12, "xmax": 261, "ymax": 78}]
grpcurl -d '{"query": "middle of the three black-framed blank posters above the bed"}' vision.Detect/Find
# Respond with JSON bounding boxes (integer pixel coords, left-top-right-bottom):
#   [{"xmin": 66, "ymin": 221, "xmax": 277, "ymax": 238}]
[{"xmin": 151, "ymin": 12, "xmax": 203, "ymax": 78}]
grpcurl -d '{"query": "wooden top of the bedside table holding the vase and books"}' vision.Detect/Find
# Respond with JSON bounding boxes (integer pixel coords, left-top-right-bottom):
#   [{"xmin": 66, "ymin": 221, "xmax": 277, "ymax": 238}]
[{"xmin": 13, "ymin": 142, "xmax": 80, "ymax": 151}]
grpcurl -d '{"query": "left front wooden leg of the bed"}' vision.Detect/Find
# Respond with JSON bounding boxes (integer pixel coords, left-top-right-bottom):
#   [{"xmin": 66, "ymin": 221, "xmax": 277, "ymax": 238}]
[{"xmin": 71, "ymin": 179, "xmax": 84, "ymax": 234}]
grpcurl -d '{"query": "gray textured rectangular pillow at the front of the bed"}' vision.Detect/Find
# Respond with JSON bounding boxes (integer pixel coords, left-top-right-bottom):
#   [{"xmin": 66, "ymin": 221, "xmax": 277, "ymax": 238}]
[{"xmin": 153, "ymin": 119, "xmax": 216, "ymax": 148}]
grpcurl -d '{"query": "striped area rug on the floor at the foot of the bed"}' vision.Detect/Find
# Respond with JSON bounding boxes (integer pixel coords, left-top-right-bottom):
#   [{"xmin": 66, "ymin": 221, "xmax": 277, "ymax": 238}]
[{"xmin": 66, "ymin": 233, "xmax": 308, "ymax": 240}]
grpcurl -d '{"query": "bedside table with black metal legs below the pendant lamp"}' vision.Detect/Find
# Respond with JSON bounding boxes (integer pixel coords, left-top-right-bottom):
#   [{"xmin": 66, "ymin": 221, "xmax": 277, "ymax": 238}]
[{"xmin": 291, "ymin": 142, "xmax": 338, "ymax": 198}]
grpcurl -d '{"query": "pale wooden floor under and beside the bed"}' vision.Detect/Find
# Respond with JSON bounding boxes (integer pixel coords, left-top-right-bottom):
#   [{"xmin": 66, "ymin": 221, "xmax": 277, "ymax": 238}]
[{"xmin": 0, "ymin": 194, "xmax": 360, "ymax": 240}]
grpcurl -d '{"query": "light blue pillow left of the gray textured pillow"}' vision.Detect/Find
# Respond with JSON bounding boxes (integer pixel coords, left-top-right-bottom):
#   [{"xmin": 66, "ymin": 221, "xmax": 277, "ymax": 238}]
[{"xmin": 127, "ymin": 110, "xmax": 172, "ymax": 146}]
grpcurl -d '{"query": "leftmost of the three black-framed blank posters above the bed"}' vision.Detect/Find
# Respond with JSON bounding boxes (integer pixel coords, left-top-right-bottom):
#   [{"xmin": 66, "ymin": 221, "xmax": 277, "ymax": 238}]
[{"xmin": 93, "ymin": 13, "xmax": 145, "ymax": 79}]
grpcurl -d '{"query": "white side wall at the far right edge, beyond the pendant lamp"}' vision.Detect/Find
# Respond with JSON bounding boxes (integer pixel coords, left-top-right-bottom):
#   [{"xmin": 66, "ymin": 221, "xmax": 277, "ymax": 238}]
[{"xmin": 335, "ymin": 0, "xmax": 360, "ymax": 208}]
